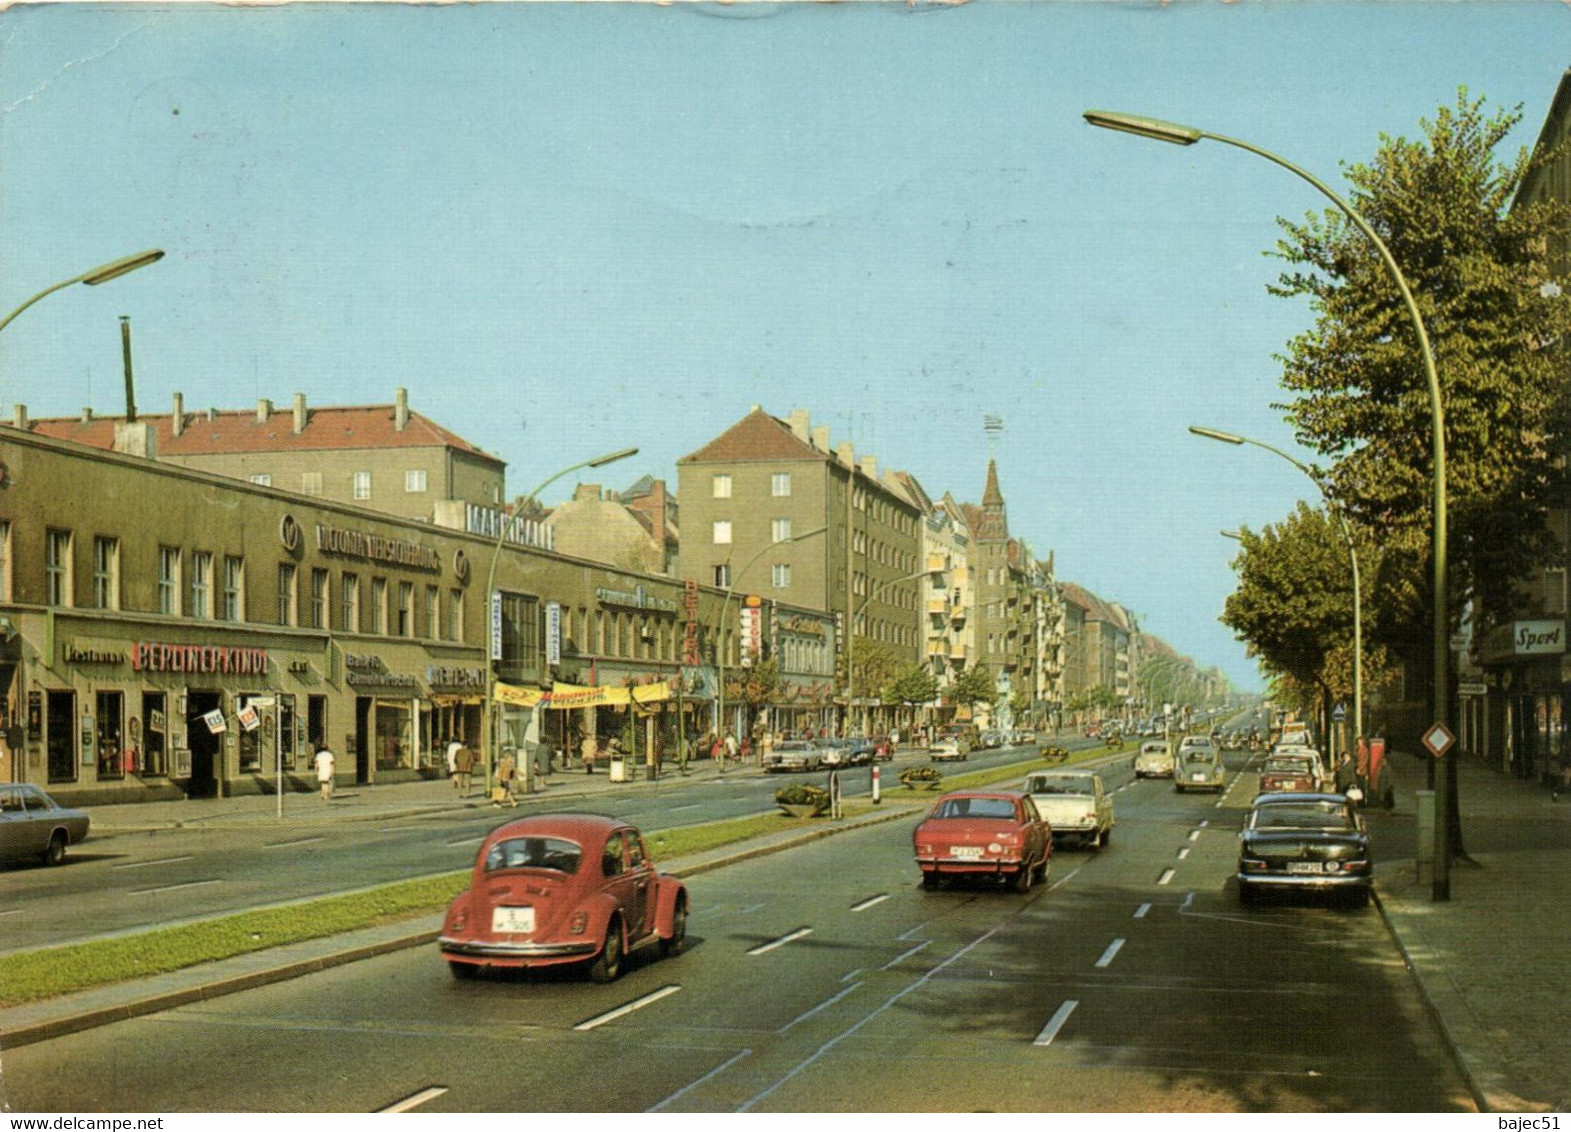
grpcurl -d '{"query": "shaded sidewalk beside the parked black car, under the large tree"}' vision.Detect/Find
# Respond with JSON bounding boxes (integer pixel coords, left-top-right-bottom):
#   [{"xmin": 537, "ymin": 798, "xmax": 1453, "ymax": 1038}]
[{"xmin": 1368, "ymin": 755, "xmax": 1571, "ymax": 1112}]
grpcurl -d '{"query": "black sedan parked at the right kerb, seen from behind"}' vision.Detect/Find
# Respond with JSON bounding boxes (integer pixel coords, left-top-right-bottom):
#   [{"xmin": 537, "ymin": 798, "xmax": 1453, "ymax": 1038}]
[{"xmin": 1238, "ymin": 793, "xmax": 1375, "ymax": 906}]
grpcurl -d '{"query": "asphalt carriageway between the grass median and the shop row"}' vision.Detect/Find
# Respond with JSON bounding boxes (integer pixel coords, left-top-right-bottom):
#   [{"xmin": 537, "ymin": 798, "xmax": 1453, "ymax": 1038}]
[{"xmin": 0, "ymin": 739, "xmax": 1087, "ymax": 953}]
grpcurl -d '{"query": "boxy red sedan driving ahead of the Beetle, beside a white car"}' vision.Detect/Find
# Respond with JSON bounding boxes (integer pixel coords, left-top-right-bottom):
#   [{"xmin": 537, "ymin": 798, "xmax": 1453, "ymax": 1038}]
[{"xmin": 911, "ymin": 790, "xmax": 1053, "ymax": 892}]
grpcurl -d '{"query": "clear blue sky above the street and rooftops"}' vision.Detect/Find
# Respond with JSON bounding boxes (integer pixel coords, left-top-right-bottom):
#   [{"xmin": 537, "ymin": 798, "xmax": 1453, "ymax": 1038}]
[{"xmin": 0, "ymin": 0, "xmax": 1571, "ymax": 688}]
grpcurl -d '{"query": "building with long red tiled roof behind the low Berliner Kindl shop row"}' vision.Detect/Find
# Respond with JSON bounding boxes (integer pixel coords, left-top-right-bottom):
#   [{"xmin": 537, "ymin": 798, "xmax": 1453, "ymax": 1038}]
[{"xmin": 14, "ymin": 389, "xmax": 506, "ymax": 521}]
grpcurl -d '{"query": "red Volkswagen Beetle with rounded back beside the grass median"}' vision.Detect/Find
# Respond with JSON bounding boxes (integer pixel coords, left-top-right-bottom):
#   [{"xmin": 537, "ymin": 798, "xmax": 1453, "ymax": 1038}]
[{"xmin": 437, "ymin": 813, "xmax": 688, "ymax": 983}]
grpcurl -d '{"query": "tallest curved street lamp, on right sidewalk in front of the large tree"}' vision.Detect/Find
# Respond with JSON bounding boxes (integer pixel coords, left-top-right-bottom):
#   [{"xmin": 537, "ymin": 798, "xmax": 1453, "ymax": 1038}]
[{"xmin": 1082, "ymin": 110, "xmax": 1455, "ymax": 901}]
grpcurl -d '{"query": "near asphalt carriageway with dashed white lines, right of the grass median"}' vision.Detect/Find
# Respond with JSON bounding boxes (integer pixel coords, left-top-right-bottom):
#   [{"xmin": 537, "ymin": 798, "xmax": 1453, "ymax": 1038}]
[{"xmin": 0, "ymin": 741, "xmax": 1469, "ymax": 1112}]
